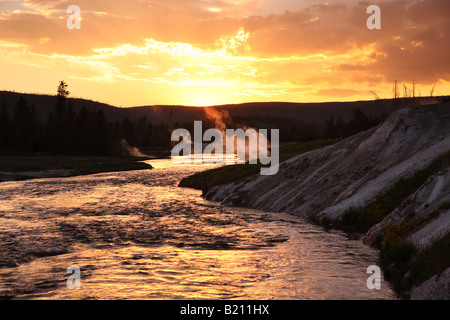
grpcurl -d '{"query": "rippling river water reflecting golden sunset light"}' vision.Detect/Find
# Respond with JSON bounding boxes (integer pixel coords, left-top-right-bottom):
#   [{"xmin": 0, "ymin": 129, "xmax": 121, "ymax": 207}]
[{"xmin": 0, "ymin": 160, "xmax": 395, "ymax": 300}]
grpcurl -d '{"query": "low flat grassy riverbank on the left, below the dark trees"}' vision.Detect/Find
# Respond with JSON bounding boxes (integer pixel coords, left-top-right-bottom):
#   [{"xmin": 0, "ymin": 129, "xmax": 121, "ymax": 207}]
[{"xmin": 0, "ymin": 156, "xmax": 152, "ymax": 182}]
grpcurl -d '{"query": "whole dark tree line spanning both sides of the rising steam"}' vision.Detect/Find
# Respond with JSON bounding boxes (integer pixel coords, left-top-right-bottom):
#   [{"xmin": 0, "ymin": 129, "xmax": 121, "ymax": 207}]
[{"xmin": 0, "ymin": 81, "xmax": 382, "ymax": 156}]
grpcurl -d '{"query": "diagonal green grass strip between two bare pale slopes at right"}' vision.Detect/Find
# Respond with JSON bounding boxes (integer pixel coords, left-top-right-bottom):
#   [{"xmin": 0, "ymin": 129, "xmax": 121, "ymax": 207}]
[{"xmin": 333, "ymin": 151, "xmax": 450, "ymax": 232}]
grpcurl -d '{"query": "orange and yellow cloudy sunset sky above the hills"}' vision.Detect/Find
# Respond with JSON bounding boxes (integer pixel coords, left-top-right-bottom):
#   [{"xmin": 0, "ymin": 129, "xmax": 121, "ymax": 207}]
[{"xmin": 0, "ymin": 0, "xmax": 450, "ymax": 107}]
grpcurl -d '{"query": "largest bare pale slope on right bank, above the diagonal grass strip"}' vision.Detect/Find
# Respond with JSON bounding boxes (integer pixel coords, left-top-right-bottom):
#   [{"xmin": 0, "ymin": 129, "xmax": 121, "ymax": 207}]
[{"xmin": 206, "ymin": 104, "xmax": 450, "ymax": 218}]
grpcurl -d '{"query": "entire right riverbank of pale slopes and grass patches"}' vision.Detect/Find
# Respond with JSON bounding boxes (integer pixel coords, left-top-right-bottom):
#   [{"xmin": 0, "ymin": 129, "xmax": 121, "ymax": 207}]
[{"xmin": 178, "ymin": 103, "xmax": 450, "ymax": 299}]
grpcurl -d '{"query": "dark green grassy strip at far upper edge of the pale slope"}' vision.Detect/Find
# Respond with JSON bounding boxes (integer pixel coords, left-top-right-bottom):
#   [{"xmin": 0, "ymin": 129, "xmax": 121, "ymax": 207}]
[{"xmin": 180, "ymin": 140, "xmax": 337, "ymax": 193}]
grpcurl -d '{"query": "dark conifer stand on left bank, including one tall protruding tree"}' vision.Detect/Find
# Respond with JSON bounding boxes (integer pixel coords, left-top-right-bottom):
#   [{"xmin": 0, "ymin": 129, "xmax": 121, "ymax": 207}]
[{"xmin": 0, "ymin": 81, "xmax": 170, "ymax": 156}]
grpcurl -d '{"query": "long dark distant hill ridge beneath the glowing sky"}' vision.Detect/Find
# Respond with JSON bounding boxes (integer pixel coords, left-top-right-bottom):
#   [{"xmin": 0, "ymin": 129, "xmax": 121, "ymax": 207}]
[{"xmin": 0, "ymin": 91, "xmax": 444, "ymax": 125}]
